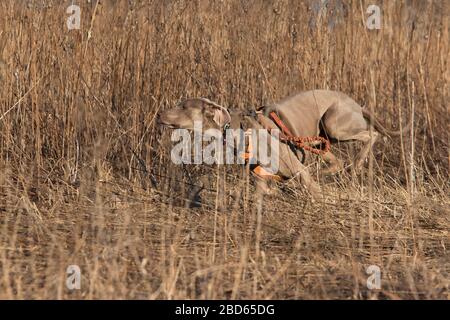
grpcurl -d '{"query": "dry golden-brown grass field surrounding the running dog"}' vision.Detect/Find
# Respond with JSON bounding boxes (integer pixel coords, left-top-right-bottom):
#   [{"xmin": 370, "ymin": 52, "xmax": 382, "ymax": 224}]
[{"xmin": 0, "ymin": 0, "xmax": 450, "ymax": 299}]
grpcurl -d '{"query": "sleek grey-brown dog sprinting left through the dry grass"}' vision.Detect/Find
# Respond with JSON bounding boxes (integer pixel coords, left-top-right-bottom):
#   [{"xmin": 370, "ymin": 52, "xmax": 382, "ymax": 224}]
[{"xmin": 159, "ymin": 90, "xmax": 409, "ymax": 195}]
